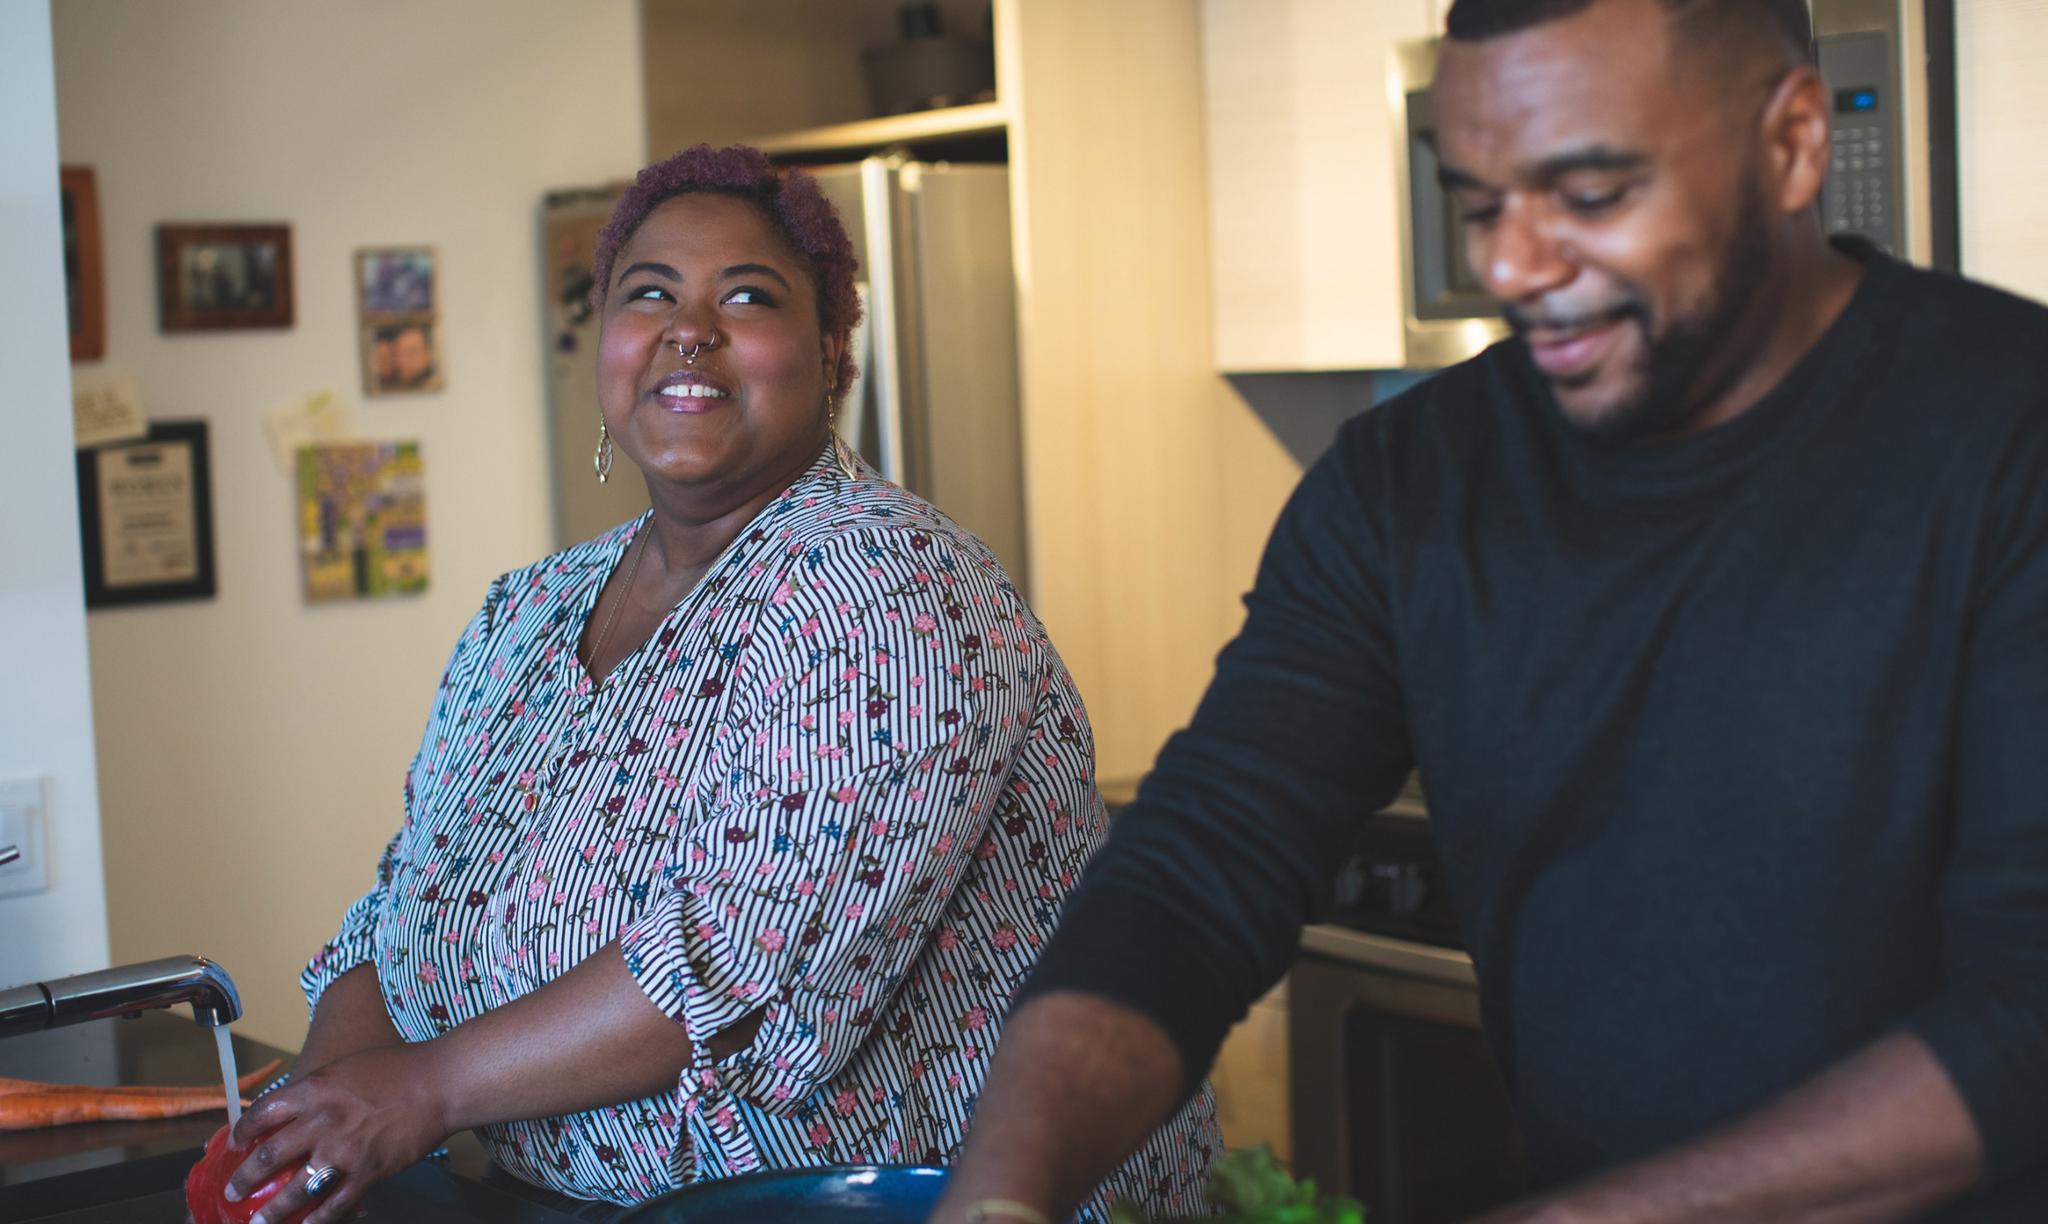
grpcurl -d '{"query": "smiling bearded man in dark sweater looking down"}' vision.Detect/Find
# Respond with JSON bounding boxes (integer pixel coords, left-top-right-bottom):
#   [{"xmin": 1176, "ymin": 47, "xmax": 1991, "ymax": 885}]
[{"xmin": 934, "ymin": 0, "xmax": 2048, "ymax": 1224}]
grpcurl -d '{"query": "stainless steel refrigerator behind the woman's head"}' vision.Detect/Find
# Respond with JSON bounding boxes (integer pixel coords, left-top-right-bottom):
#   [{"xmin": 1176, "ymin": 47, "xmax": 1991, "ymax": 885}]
[{"xmin": 543, "ymin": 158, "xmax": 1028, "ymax": 587}]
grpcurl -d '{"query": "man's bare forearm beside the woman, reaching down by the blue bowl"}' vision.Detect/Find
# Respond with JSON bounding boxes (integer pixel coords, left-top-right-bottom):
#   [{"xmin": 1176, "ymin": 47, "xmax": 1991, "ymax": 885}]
[{"xmin": 932, "ymin": 991, "xmax": 1186, "ymax": 1224}]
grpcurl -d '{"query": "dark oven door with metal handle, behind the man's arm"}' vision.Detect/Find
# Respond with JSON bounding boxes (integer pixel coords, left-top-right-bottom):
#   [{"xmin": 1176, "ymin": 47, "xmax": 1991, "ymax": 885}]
[{"xmin": 1288, "ymin": 927, "xmax": 1528, "ymax": 1224}]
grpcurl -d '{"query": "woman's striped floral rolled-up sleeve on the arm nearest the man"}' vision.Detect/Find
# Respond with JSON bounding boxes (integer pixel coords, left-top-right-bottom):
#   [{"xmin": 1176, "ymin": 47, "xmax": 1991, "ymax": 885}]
[{"xmin": 621, "ymin": 528, "xmax": 1019, "ymax": 1113}]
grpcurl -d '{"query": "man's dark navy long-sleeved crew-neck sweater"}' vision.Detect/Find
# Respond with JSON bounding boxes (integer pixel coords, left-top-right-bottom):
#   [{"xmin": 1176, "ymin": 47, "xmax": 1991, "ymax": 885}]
[{"xmin": 1026, "ymin": 248, "xmax": 2048, "ymax": 1220}]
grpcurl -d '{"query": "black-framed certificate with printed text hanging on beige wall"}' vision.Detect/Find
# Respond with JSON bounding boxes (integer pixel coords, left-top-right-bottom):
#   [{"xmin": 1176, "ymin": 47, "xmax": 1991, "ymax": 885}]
[{"xmin": 78, "ymin": 422, "xmax": 215, "ymax": 608}]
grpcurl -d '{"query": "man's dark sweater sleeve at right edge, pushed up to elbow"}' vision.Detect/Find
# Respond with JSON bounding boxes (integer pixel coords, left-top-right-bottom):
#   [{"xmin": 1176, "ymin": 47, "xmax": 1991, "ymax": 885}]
[{"xmin": 1909, "ymin": 419, "xmax": 2048, "ymax": 1185}]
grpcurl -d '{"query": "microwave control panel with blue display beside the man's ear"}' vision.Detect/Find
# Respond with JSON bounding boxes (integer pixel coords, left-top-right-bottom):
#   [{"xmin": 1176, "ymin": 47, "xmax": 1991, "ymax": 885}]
[{"xmin": 1821, "ymin": 31, "xmax": 1905, "ymax": 256}]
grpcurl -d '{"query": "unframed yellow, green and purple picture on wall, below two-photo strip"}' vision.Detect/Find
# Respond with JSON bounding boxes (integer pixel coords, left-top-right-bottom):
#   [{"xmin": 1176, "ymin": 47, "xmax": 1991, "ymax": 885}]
[{"xmin": 299, "ymin": 442, "xmax": 428, "ymax": 602}]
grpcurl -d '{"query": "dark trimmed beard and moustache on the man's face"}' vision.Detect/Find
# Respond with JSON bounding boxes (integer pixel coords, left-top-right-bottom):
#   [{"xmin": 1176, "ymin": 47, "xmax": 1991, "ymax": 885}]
[{"xmin": 1503, "ymin": 176, "xmax": 1772, "ymax": 442}]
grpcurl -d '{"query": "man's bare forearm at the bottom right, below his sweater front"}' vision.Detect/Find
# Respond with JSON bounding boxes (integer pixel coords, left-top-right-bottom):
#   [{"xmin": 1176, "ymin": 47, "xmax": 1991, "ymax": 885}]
[{"xmin": 1475, "ymin": 1034, "xmax": 1985, "ymax": 1224}]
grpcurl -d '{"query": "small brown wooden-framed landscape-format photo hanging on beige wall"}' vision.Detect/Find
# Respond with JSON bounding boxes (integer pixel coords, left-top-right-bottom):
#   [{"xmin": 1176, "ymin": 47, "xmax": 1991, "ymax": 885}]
[{"xmin": 156, "ymin": 225, "xmax": 291, "ymax": 332}]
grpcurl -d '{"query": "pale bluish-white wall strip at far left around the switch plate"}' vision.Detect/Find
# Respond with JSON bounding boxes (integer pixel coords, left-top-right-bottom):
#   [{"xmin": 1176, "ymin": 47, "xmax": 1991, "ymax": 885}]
[{"xmin": 0, "ymin": 0, "xmax": 106, "ymax": 987}]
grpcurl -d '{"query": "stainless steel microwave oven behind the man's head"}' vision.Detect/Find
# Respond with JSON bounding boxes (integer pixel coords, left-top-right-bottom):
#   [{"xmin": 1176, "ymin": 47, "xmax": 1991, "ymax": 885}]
[{"xmin": 1386, "ymin": 0, "xmax": 1958, "ymax": 368}]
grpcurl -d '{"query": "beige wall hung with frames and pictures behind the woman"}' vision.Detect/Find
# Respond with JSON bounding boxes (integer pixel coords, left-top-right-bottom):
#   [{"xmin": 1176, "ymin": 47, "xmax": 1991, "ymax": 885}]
[{"xmin": 55, "ymin": 0, "xmax": 645, "ymax": 1046}]
